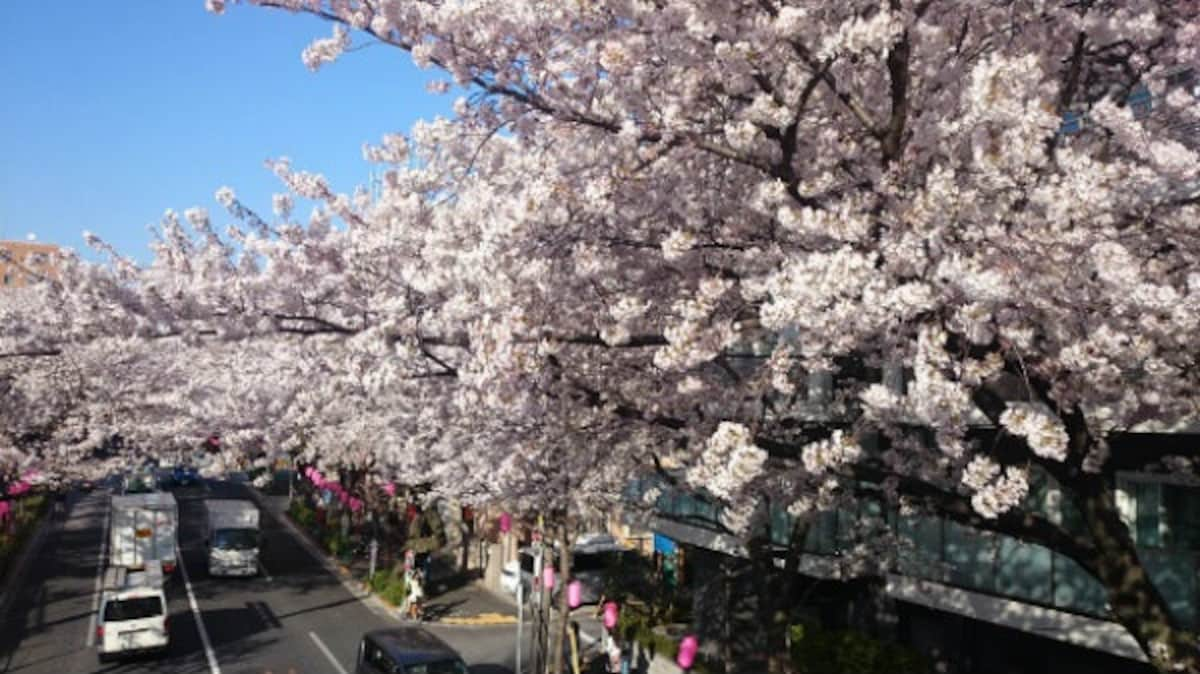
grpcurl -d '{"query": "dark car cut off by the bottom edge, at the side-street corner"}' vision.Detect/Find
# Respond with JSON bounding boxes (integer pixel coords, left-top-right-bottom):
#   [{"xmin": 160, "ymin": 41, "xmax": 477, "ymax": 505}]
[{"xmin": 354, "ymin": 627, "xmax": 467, "ymax": 674}]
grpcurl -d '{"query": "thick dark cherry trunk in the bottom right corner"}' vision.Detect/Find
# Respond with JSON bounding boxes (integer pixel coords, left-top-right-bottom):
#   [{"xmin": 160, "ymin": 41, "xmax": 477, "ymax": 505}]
[{"xmin": 1076, "ymin": 476, "xmax": 1200, "ymax": 674}]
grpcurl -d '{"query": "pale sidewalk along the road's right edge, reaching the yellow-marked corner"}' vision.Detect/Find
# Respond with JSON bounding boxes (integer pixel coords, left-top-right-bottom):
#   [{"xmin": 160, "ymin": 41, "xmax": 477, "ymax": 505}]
[{"xmin": 247, "ymin": 487, "xmax": 517, "ymax": 625}]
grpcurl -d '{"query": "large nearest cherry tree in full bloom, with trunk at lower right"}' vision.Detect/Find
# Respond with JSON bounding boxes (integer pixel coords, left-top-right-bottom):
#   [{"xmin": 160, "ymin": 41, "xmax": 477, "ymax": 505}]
[{"xmin": 192, "ymin": 0, "xmax": 1200, "ymax": 670}]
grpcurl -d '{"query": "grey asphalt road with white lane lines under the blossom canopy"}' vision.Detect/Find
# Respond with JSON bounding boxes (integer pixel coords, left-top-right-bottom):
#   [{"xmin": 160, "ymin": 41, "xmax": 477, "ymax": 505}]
[{"xmin": 0, "ymin": 483, "xmax": 525, "ymax": 674}]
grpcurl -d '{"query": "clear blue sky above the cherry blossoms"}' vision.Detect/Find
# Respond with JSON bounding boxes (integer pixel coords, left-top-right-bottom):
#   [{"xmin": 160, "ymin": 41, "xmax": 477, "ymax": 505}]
[{"xmin": 0, "ymin": 0, "xmax": 454, "ymax": 261}]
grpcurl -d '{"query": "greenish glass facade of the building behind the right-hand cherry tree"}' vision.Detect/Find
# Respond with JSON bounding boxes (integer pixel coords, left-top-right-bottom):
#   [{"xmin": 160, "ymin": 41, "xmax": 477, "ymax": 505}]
[{"xmin": 626, "ymin": 477, "xmax": 1200, "ymax": 630}]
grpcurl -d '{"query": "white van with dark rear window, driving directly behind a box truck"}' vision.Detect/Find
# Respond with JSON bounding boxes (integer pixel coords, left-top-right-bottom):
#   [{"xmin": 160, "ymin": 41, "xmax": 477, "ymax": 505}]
[{"xmin": 96, "ymin": 562, "xmax": 170, "ymax": 662}]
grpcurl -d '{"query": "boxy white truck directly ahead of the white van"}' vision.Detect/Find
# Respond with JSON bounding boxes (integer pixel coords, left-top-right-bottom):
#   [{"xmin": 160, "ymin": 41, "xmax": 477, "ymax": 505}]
[{"xmin": 108, "ymin": 492, "xmax": 179, "ymax": 573}]
